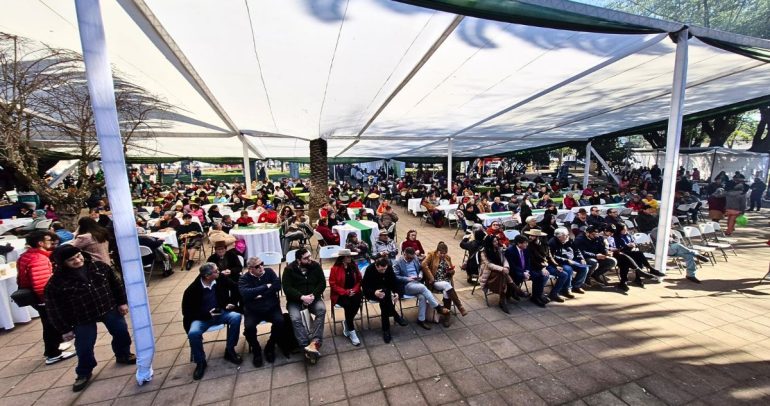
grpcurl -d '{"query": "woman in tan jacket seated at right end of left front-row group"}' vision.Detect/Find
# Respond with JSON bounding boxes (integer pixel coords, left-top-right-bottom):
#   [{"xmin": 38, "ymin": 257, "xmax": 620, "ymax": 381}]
[{"xmin": 422, "ymin": 241, "xmax": 468, "ymax": 327}]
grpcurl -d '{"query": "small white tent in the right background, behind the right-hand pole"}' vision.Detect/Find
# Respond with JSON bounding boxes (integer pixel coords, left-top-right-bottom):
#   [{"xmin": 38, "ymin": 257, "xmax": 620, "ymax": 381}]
[{"xmin": 631, "ymin": 147, "xmax": 770, "ymax": 180}]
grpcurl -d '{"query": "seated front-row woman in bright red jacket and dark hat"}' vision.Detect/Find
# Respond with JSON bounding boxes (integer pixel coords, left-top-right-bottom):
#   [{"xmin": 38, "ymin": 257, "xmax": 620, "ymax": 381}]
[{"xmin": 329, "ymin": 248, "xmax": 361, "ymax": 346}]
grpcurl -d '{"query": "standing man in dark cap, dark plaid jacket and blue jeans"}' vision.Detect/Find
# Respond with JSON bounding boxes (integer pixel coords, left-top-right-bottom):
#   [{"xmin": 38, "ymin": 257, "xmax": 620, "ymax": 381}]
[{"xmin": 45, "ymin": 245, "xmax": 136, "ymax": 392}]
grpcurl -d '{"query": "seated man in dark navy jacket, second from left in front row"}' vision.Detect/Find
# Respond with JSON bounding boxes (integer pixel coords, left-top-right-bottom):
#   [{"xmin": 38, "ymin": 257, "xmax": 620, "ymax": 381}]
[{"xmin": 238, "ymin": 257, "xmax": 289, "ymax": 368}]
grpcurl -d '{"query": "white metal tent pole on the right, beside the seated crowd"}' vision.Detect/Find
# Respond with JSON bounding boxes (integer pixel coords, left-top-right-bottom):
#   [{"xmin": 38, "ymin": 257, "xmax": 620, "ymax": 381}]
[{"xmin": 655, "ymin": 28, "xmax": 689, "ymax": 270}]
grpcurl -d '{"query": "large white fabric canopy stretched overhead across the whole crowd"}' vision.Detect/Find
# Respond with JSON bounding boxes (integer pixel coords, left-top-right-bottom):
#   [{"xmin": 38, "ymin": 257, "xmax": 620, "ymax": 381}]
[{"xmin": 0, "ymin": 0, "xmax": 770, "ymax": 159}]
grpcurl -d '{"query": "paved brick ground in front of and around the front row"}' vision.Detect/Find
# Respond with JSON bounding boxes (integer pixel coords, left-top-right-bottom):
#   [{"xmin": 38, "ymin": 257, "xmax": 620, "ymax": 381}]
[{"xmin": 0, "ymin": 209, "xmax": 770, "ymax": 406}]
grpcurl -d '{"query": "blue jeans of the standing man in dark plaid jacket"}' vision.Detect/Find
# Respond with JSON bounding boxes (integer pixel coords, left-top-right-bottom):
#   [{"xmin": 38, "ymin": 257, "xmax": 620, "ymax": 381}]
[{"xmin": 72, "ymin": 309, "xmax": 131, "ymax": 376}]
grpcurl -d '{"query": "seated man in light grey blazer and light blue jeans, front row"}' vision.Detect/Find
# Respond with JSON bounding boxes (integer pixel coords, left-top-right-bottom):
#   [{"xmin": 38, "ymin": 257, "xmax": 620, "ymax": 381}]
[{"xmin": 392, "ymin": 247, "xmax": 449, "ymax": 330}]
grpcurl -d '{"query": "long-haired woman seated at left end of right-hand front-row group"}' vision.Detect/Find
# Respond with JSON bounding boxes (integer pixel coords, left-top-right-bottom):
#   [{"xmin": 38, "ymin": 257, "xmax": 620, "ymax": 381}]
[{"xmin": 479, "ymin": 235, "xmax": 514, "ymax": 313}]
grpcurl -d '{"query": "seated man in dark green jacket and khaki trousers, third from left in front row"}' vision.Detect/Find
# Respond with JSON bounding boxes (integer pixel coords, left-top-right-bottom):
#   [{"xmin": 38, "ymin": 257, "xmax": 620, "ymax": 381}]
[{"xmin": 281, "ymin": 247, "xmax": 326, "ymax": 364}]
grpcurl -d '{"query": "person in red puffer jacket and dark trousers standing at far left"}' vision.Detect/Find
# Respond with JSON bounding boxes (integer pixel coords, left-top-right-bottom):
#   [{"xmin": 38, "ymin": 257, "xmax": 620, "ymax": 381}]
[{"xmin": 16, "ymin": 231, "xmax": 75, "ymax": 365}]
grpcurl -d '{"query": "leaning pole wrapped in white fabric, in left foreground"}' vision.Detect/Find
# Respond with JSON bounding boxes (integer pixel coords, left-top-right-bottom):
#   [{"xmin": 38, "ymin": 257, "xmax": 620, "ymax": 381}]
[{"xmin": 75, "ymin": 0, "xmax": 155, "ymax": 385}]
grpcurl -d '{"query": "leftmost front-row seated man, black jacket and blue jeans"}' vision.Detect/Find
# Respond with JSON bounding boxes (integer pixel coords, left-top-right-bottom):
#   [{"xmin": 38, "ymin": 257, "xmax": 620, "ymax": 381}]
[{"xmin": 182, "ymin": 262, "xmax": 242, "ymax": 380}]
